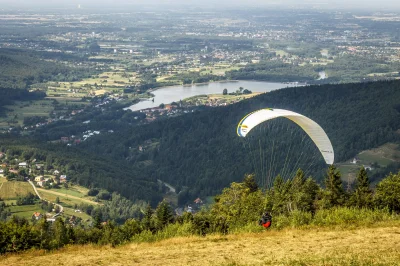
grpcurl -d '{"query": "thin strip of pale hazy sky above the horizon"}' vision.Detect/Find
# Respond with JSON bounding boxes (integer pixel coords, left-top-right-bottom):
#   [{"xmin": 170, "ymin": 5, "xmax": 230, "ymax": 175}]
[{"xmin": 0, "ymin": 0, "xmax": 400, "ymax": 11}]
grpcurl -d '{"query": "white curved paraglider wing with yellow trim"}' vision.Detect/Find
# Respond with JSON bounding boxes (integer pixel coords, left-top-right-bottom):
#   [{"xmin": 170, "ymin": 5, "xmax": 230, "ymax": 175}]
[{"xmin": 237, "ymin": 109, "xmax": 335, "ymax": 164}]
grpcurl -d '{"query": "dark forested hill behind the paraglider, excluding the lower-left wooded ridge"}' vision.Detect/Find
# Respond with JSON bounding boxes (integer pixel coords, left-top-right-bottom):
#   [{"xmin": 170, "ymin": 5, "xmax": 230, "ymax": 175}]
[{"xmin": 23, "ymin": 81, "xmax": 400, "ymax": 203}]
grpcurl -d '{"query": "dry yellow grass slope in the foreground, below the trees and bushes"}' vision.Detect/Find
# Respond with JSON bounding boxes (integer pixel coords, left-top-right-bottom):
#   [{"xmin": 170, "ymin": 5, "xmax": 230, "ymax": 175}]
[{"xmin": 0, "ymin": 222, "xmax": 400, "ymax": 265}]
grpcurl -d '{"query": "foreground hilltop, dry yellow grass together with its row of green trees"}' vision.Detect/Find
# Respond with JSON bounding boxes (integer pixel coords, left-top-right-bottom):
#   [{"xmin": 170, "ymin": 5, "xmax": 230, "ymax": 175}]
[{"xmin": 0, "ymin": 166, "xmax": 400, "ymax": 265}]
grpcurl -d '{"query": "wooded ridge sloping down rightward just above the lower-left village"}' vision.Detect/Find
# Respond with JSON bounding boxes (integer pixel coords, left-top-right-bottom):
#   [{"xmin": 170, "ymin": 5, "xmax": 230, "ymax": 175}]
[{"xmin": 0, "ymin": 137, "xmax": 163, "ymax": 205}]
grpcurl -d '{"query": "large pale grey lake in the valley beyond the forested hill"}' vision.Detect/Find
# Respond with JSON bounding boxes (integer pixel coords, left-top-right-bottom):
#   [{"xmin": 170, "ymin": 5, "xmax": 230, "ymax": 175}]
[{"xmin": 126, "ymin": 80, "xmax": 299, "ymax": 111}]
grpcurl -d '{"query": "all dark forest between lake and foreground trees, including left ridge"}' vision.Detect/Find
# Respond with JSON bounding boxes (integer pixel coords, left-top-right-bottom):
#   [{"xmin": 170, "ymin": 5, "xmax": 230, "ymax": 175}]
[{"xmin": 0, "ymin": 81, "xmax": 400, "ymax": 206}]
